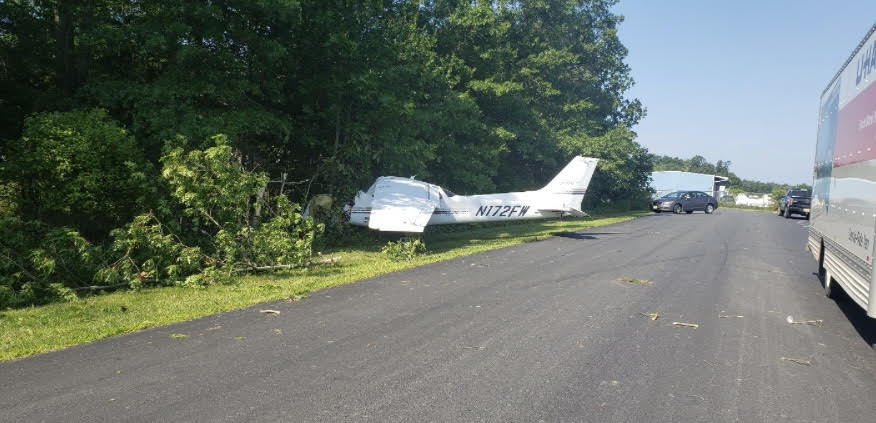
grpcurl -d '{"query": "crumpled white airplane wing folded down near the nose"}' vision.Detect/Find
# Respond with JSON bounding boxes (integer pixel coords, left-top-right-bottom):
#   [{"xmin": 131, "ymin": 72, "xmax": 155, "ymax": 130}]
[{"xmin": 368, "ymin": 177, "xmax": 438, "ymax": 232}]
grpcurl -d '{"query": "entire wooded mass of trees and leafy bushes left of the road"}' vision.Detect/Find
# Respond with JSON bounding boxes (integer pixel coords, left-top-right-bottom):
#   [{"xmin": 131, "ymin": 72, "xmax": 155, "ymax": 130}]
[{"xmin": 0, "ymin": 0, "xmax": 651, "ymax": 306}]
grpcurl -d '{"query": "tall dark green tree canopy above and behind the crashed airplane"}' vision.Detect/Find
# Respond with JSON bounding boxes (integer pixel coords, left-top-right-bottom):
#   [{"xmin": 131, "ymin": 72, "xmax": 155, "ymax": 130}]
[{"xmin": 0, "ymin": 0, "xmax": 644, "ymax": 202}]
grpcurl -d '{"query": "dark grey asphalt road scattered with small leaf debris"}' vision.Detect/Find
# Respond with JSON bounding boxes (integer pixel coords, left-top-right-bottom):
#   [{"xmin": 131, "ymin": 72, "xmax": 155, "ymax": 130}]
[{"xmin": 0, "ymin": 209, "xmax": 876, "ymax": 422}]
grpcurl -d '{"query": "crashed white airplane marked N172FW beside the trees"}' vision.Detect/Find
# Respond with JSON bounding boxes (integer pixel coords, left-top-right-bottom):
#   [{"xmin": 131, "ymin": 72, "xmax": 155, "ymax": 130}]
[{"xmin": 349, "ymin": 156, "xmax": 599, "ymax": 232}]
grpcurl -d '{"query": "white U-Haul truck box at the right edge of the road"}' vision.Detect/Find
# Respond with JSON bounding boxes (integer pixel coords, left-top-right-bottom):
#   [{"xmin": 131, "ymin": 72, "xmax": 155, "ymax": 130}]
[{"xmin": 807, "ymin": 20, "xmax": 876, "ymax": 318}]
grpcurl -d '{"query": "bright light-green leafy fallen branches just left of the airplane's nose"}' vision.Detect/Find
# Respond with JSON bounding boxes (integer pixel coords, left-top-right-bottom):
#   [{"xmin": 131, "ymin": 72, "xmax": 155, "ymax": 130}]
[{"xmin": 98, "ymin": 136, "xmax": 322, "ymax": 288}]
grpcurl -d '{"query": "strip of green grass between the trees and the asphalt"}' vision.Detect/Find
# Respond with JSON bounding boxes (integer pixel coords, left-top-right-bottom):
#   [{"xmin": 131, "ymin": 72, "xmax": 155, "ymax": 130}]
[{"xmin": 0, "ymin": 212, "xmax": 648, "ymax": 361}]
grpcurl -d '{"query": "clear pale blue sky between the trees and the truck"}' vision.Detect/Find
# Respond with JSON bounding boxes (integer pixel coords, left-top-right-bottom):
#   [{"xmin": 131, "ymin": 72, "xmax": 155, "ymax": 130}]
[{"xmin": 614, "ymin": 0, "xmax": 876, "ymax": 184}]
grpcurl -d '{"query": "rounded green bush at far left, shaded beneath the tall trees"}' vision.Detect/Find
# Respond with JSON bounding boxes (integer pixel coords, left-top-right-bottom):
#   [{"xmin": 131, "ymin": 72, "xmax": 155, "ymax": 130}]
[{"xmin": 3, "ymin": 109, "xmax": 154, "ymax": 239}]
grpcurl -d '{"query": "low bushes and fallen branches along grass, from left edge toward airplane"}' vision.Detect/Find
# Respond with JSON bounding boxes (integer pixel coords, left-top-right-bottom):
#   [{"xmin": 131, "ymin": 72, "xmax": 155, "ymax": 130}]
[{"xmin": 0, "ymin": 132, "xmax": 322, "ymax": 308}]
